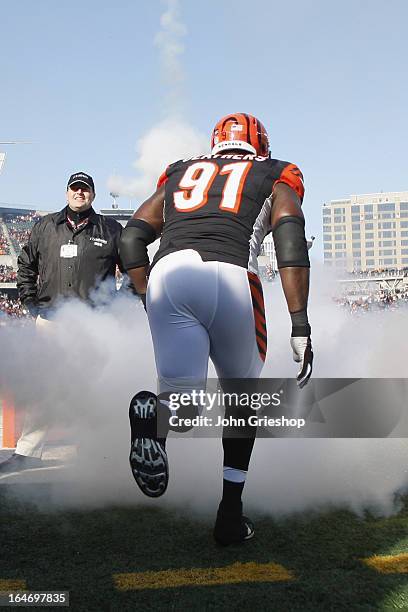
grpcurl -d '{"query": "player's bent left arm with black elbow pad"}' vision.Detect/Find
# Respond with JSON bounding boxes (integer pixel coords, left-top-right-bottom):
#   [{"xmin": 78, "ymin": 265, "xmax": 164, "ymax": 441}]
[{"xmin": 119, "ymin": 185, "xmax": 165, "ymax": 304}]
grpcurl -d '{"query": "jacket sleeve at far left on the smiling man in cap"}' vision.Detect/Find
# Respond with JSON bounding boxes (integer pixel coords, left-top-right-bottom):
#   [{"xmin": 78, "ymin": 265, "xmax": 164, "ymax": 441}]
[{"xmin": 17, "ymin": 221, "xmax": 41, "ymax": 304}]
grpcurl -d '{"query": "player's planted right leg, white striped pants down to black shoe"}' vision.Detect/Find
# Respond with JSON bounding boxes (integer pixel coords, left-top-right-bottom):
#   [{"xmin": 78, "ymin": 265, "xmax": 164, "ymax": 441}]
[{"xmin": 210, "ymin": 264, "xmax": 267, "ymax": 544}]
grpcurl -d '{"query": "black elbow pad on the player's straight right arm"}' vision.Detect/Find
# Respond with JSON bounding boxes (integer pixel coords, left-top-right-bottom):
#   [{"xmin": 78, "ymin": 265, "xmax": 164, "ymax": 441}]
[{"xmin": 273, "ymin": 217, "xmax": 310, "ymax": 268}]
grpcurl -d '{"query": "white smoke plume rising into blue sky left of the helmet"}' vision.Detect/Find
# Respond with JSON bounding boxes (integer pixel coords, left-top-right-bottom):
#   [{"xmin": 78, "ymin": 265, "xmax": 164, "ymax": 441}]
[{"xmin": 108, "ymin": 0, "xmax": 209, "ymax": 204}]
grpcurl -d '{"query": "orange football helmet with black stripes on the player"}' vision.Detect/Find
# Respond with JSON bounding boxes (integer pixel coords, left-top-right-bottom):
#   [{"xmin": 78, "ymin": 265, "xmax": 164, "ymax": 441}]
[{"xmin": 211, "ymin": 113, "xmax": 269, "ymax": 157}]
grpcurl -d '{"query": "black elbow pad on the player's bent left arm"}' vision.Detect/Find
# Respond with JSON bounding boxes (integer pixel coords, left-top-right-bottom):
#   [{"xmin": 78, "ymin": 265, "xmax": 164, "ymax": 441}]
[{"xmin": 119, "ymin": 219, "xmax": 156, "ymax": 271}]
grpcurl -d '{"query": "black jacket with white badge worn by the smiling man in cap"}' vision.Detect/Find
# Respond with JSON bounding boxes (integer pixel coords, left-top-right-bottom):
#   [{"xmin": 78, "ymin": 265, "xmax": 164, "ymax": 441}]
[{"xmin": 17, "ymin": 208, "xmax": 122, "ymax": 316}]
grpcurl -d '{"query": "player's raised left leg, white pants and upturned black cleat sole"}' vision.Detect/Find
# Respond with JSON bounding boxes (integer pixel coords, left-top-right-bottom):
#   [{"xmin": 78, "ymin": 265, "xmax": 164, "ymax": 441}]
[{"xmin": 129, "ymin": 251, "xmax": 216, "ymax": 497}]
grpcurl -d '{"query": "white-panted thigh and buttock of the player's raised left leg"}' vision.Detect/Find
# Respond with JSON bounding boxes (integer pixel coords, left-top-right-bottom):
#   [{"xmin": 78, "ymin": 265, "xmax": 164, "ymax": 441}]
[{"xmin": 147, "ymin": 250, "xmax": 216, "ymax": 393}]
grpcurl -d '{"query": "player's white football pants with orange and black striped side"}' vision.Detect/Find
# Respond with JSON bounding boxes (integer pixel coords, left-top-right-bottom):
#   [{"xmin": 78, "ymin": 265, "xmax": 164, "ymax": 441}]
[{"xmin": 147, "ymin": 249, "xmax": 266, "ymax": 393}]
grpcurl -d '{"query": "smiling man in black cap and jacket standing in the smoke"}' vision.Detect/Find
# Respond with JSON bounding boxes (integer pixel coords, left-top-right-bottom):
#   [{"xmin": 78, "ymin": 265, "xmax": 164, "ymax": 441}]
[{"xmin": 0, "ymin": 172, "xmax": 122, "ymax": 478}]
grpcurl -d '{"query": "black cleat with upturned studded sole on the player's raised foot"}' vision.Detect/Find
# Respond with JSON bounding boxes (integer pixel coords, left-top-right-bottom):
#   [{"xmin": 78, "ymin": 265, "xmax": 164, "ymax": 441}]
[{"xmin": 129, "ymin": 391, "xmax": 169, "ymax": 497}]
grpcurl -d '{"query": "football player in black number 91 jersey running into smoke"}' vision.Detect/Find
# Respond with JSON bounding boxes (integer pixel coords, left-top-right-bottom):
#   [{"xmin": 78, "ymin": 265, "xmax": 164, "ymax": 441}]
[{"xmin": 121, "ymin": 113, "xmax": 313, "ymax": 545}]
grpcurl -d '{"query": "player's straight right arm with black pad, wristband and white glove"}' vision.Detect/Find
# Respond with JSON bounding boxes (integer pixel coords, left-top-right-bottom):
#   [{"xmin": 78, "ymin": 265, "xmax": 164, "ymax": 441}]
[{"xmin": 271, "ymin": 182, "xmax": 313, "ymax": 387}]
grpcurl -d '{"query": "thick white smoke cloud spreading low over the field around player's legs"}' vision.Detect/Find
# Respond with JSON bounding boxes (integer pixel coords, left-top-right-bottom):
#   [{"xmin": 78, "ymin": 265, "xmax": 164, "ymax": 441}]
[{"xmin": 0, "ymin": 266, "xmax": 408, "ymax": 515}]
